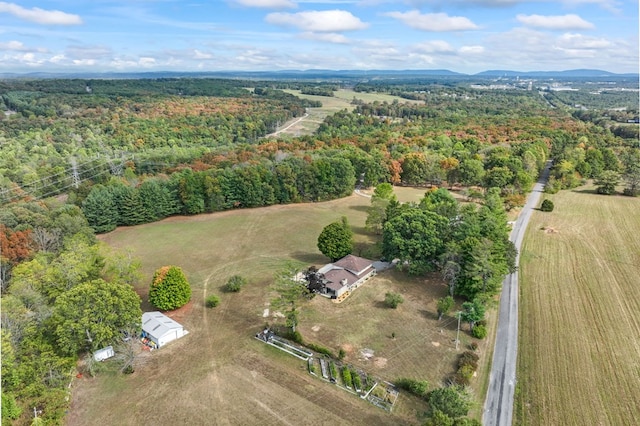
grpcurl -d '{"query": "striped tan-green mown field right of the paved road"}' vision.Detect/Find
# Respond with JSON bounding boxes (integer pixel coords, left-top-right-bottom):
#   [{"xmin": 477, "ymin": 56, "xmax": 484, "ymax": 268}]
[{"xmin": 514, "ymin": 188, "xmax": 640, "ymax": 425}]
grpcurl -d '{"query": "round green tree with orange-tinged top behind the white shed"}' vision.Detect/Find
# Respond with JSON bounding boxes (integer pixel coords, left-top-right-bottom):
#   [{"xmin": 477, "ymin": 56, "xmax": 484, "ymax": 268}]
[{"xmin": 149, "ymin": 266, "xmax": 191, "ymax": 311}]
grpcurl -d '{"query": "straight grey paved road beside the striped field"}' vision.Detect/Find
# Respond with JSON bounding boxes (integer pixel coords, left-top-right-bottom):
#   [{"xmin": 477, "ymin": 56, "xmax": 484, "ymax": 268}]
[{"xmin": 482, "ymin": 162, "xmax": 551, "ymax": 426}]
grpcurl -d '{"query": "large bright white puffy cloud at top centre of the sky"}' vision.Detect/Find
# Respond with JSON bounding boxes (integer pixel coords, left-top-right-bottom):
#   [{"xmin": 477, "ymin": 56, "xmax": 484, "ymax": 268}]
[{"xmin": 265, "ymin": 10, "xmax": 369, "ymax": 33}]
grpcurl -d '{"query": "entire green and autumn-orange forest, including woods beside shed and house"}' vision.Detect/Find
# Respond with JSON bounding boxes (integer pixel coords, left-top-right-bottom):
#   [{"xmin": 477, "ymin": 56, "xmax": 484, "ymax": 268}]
[{"xmin": 0, "ymin": 75, "xmax": 640, "ymax": 424}]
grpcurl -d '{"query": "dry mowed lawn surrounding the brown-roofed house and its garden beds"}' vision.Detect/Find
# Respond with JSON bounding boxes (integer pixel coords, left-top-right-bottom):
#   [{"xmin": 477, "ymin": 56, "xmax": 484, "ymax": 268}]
[{"xmin": 67, "ymin": 195, "xmax": 484, "ymax": 425}]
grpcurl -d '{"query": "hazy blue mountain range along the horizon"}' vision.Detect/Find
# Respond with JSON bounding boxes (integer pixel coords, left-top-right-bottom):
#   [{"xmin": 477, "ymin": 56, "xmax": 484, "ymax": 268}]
[{"xmin": 0, "ymin": 69, "xmax": 639, "ymax": 80}]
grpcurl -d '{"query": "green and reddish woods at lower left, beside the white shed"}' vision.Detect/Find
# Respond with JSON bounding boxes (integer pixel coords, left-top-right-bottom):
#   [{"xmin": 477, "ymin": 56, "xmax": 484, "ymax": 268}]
[{"xmin": 0, "ymin": 201, "xmax": 141, "ymax": 425}]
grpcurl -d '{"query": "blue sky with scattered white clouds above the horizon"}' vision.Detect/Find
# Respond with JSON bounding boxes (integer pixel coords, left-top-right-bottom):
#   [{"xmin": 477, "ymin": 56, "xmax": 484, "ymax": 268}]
[{"xmin": 0, "ymin": 0, "xmax": 639, "ymax": 73}]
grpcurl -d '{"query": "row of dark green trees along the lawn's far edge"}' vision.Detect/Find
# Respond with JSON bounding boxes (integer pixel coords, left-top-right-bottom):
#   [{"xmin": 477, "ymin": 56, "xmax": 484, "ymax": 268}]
[{"xmin": 78, "ymin": 156, "xmax": 355, "ymax": 232}]
